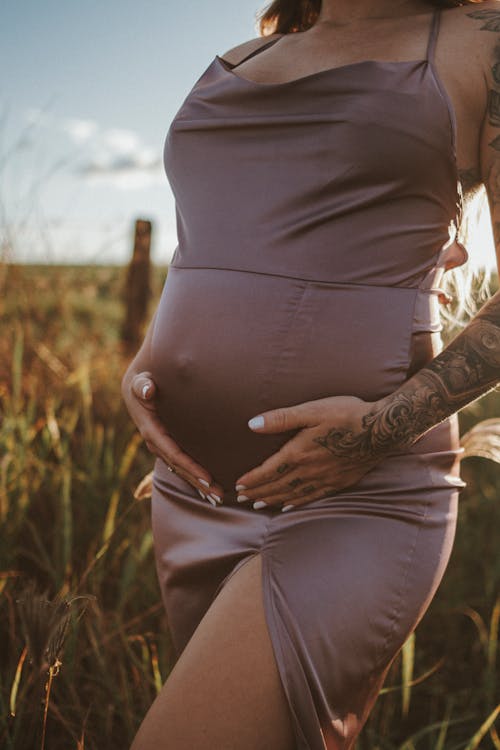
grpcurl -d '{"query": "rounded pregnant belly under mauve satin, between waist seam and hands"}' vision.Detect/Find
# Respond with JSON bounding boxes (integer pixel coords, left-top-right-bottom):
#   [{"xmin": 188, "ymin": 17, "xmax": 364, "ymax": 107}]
[{"xmin": 151, "ymin": 266, "xmax": 416, "ymax": 491}]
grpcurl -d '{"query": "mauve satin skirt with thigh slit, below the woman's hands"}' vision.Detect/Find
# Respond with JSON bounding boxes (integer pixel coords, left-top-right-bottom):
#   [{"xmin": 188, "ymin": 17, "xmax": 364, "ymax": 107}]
[{"xmin": 152, "ymin": 440, "xmax": 462, "ymax": 750}]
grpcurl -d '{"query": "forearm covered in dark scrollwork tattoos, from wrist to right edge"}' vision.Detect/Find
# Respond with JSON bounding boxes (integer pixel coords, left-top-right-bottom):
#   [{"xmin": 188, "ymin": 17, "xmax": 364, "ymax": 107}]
[{"xmin": 316, "ymin": 292, "xmax": 500, "ymax": 460}]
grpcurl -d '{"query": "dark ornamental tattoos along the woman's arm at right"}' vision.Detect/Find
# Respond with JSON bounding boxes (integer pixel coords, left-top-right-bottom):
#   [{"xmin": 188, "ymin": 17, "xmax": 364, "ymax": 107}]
[{"xmin": 317, "ymin": 9, "xmax": 500, "ymax": 462}]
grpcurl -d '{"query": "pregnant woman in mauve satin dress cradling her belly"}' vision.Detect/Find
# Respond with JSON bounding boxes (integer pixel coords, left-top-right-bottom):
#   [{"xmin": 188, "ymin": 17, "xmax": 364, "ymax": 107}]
[{"xmin": 122, "ymin": 0, "xmax": 500, "ymax": 750}]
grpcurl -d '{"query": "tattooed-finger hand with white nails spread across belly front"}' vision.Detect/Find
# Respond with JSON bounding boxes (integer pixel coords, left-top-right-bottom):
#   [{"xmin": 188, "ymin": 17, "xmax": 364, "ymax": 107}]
[{"xmin": 236, "ymin": 396, "xmax": 394, "ymax": 510}]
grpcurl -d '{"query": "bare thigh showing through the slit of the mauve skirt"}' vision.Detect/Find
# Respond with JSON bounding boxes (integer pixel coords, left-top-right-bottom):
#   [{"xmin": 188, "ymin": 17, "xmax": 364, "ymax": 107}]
[{"xmin": 131, "ymin": 554, "xmax": 296, "ymax": 750}]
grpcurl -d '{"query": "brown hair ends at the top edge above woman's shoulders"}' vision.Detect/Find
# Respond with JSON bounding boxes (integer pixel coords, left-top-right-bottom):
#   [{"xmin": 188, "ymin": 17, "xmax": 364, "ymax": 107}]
[{"xmin": 258, "ymin": 0, "xmax": 483, "ymax": 36}]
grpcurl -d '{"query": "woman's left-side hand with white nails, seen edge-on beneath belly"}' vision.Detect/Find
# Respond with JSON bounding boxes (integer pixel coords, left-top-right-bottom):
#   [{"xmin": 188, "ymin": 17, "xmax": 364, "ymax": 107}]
[{"xmin": 121, "ymin": 371, "xmax": 224, "ymax": 505}]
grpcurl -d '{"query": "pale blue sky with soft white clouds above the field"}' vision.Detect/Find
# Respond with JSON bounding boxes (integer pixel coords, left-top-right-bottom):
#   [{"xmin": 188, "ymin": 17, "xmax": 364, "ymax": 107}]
[{"xmin": 0, "ymin": 0, "xmax": 495, "ymax": 266}]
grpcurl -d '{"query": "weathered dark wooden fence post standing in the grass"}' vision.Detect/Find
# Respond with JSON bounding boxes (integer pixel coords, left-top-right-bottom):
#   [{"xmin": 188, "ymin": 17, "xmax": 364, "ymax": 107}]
[{"xmin": 122, "ymin": 219, "xmax": 151, "ymax": 350}]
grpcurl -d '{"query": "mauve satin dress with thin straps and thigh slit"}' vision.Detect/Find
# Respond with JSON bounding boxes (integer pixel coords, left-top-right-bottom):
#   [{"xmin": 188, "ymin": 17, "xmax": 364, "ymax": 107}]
[{"xmin": 151, "ymin": 11, "xmax": 467, "ymax": 750}]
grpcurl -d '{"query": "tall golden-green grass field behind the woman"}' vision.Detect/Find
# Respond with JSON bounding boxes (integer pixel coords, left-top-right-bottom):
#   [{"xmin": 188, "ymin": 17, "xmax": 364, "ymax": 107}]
[{"xmin": 0, "ymin": 265, "xmax": 500, "ymax": 750}]
